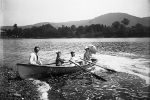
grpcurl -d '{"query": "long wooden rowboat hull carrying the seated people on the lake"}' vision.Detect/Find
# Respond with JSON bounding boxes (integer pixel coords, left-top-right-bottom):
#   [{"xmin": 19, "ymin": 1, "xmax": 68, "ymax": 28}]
[{"xmin": 17, "ymin": 63, "xmax": 91, "ymax": 79}]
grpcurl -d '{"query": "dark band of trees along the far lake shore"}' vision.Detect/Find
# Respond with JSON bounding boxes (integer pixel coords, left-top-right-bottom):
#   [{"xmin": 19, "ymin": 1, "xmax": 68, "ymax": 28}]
[{"xmin": 1, "ymin": 18, "xmax": 150, "ymax": 38}]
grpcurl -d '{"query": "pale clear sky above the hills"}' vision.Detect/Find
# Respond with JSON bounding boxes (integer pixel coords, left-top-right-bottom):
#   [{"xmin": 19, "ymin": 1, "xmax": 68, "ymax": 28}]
[{"xmin": 0, "ymin": 0, "xmax": 150, "ymax": 26}]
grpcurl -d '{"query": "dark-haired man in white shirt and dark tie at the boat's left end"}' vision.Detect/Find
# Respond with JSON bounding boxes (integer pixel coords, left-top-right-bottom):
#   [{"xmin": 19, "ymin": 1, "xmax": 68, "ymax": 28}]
[{"xmin": 29, "ymin": 46, "xmax": 42, "ymax": 65}]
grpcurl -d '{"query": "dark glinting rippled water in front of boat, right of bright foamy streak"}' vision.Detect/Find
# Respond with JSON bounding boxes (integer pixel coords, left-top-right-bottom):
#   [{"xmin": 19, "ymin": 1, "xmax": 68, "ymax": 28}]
[{"xmin": 39, "ymin": 72, "xmax": 150, "ymax": 100}]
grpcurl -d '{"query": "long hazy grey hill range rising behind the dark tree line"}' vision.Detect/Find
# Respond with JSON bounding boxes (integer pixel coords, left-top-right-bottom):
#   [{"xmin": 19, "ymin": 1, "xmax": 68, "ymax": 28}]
[{"xmin": 2, "ymin": 13, "xmax": 150, "ymax": 29}]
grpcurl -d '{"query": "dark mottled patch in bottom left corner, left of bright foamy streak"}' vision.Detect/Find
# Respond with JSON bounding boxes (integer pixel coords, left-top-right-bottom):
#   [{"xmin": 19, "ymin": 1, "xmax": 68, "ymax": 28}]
[{"xmin": 0, "ymin": 66, "xmax": 40, "ymax": 100}]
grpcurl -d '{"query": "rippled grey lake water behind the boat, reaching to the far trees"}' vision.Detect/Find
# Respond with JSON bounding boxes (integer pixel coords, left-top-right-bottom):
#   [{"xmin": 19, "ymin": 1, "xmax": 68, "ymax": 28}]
[{"xmin": 0, "ymin": 38, "xmax": 150, "ymax": 66}]
